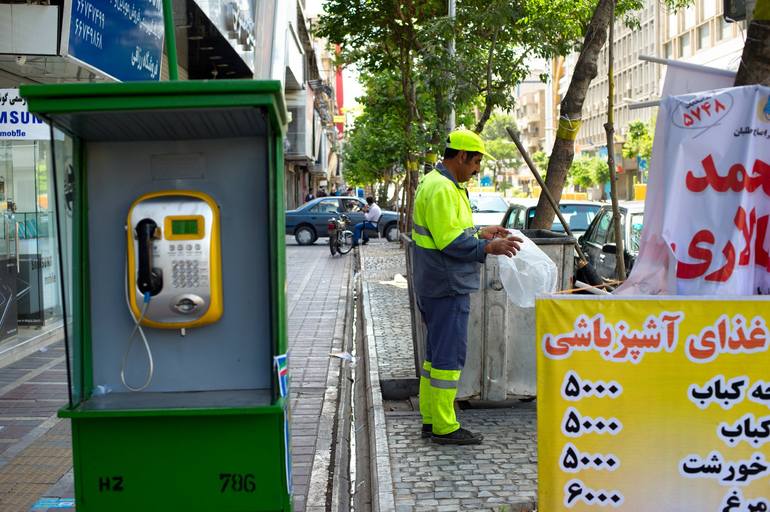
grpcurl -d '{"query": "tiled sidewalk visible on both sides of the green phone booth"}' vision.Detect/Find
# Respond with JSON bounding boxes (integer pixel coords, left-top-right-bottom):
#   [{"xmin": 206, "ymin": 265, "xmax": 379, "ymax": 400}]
[{"xmin": 0, "ymin": 237, "xmax": 352, "ymax": 512}]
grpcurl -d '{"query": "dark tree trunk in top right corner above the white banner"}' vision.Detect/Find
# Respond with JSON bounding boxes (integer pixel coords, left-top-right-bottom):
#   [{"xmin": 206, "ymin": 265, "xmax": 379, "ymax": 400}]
[{"xmin": 735, "ymin": 0, "xmax": 770, "ymax": 86}]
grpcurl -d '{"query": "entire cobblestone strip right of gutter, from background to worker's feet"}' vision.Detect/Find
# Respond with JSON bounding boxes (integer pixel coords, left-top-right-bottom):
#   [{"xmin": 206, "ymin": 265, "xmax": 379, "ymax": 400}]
[{"xmin": 361, "ymin": 241, "xmax": 537, "ymax": 512}]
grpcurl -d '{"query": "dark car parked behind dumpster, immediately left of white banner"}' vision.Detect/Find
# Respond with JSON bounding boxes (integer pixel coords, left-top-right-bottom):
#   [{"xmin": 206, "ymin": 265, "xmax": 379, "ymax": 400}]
[{"xmin": 578, "ymin": 201, "xmax": 644, "ymax": 280}]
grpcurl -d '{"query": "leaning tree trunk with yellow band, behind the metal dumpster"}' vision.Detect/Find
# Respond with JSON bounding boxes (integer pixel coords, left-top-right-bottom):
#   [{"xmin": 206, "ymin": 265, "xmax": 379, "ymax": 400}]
[{"xmin": 531, "ymin": 0, "xmax": 613, "ymax": 229}]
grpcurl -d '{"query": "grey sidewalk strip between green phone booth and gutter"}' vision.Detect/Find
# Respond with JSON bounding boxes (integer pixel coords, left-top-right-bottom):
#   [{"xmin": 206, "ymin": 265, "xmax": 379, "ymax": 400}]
[{"xmin": 286, "ymin": 238, "xmax": 353, "ymax": 512}]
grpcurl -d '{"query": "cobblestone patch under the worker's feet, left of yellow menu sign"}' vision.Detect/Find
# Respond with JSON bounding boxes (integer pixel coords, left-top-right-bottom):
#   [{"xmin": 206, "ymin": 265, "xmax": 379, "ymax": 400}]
[{"xmin": 385, "ymin": 404, "xmax": 537, "ymax": 512}]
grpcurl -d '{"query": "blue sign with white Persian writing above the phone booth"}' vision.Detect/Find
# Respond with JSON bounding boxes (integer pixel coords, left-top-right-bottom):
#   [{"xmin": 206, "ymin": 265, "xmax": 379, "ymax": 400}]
[{"xmin": 62, "ymin": 0, "xmax": 163, "ymax": 82}]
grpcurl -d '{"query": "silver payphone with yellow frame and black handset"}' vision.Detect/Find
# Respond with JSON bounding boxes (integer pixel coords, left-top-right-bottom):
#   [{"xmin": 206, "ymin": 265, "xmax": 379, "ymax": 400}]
[{"xmin": 126, "ymin": 190, "xmax": 222, "ymax": 329}]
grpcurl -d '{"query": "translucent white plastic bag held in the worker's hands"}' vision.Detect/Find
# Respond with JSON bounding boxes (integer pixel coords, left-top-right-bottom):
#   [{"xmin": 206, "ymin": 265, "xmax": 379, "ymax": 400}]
[{"xmin": 497, "ymin": 230, "xmax": 558, "ymax": 308}]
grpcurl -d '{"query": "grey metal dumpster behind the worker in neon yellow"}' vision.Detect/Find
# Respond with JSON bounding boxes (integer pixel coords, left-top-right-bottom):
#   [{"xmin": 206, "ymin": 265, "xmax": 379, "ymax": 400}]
[{"xmin": 406, "ymin": 229, "xmax": 575, "ymax": 401}]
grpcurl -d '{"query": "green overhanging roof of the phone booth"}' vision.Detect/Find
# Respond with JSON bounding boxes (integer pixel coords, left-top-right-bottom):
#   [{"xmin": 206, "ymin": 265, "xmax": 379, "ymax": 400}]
[{"xmin": 20, "ymin": 80, "xmax": 288, "ymax": 141}]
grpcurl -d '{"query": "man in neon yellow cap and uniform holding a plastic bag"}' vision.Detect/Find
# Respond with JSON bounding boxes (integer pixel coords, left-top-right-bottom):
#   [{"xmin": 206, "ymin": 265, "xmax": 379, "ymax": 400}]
[{"xmin": 412, "ymin": 129, "xmax": 522, "ymax": 444}]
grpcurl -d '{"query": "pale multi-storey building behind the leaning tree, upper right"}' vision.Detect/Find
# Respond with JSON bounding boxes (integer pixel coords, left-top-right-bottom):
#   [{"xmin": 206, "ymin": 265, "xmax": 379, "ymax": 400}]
[{"xmin": 560, "ymin": 0, "xmax": 745, "ymax": 199}]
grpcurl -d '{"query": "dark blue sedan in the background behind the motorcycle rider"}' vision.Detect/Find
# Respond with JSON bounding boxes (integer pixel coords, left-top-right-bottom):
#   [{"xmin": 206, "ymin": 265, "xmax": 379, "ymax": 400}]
[{"xmin": 286, "ymin": 196, "xmax": 398, "ymax": 245}]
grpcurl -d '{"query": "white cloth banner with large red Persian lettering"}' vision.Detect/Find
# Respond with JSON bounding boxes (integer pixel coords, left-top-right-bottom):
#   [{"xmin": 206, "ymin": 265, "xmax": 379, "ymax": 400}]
[{"xmin": 618, "ymin": 86, "xmax": 770, "ymax": 295}]
